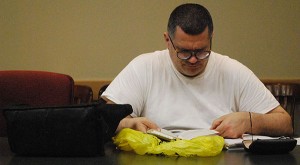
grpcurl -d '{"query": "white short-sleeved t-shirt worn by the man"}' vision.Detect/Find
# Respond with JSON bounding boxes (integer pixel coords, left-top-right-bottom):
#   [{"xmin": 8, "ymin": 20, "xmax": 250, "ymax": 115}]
[{"xmin": 103, "ymin": 50, "xmax": 279, "ymax": 129}]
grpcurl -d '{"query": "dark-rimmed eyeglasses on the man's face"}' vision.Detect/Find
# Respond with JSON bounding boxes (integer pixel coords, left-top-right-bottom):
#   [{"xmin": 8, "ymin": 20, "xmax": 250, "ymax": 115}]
[{"xmin": 169, "ymin": 35, "xmax": 211, "ymax": 60}]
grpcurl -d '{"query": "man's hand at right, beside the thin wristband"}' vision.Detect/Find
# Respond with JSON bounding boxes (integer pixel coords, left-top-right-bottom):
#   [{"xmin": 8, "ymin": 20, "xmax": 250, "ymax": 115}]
[{"xmin": 211, "ymin": 112, "xmax": 251, "ymax": 138}]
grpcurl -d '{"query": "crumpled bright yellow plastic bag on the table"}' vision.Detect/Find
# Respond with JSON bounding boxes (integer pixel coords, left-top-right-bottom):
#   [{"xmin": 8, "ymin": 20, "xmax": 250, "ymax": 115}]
[{"xmin": 113, "ymin": 128, "xmax": 224, "ymax": 157}]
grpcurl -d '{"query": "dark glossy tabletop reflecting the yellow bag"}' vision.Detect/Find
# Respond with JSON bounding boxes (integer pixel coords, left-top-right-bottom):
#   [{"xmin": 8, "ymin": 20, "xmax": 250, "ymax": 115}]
[{"xmin": 0, "ymin": 137, "xmax": 300, "ymax": 165}]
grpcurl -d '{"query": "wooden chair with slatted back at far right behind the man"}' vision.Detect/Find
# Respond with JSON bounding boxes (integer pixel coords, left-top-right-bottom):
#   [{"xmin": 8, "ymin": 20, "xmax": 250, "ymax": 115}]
[{"xmin": 265, "ymin": 83, "xmax": 300, "ymax": 131}]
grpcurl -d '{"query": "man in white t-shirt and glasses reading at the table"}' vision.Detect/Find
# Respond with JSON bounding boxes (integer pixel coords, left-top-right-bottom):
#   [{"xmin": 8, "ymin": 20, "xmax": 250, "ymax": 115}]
[{"xmin": 102, "ymin": 4, "xmax": 293, "ymax": 138}]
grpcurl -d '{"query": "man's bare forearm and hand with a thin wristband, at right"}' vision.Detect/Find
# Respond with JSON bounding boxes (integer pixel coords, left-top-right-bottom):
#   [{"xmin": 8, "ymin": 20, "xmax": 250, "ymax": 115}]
[{"xmin": 211, "ymin": 106, "xmax": 293, "ymax": 138}]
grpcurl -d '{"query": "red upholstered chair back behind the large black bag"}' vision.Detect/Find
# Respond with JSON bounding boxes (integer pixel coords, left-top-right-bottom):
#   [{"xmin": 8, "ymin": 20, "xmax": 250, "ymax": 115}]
[{"xmin": 0, "ymin": 70, "xmax": 74, "ymax": 136}]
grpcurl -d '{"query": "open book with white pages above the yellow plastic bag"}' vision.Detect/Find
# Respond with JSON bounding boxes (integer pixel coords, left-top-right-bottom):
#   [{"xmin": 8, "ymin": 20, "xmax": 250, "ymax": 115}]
[{"xmin": 147, "ymin": 129, "xmax": 218, "ymax": 141}]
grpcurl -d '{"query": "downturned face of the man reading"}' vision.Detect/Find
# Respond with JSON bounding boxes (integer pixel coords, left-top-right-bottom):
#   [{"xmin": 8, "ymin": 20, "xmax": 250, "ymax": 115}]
[{"xmin": 164, "ymin": 27, "xmax": 211, "ymax": 77}]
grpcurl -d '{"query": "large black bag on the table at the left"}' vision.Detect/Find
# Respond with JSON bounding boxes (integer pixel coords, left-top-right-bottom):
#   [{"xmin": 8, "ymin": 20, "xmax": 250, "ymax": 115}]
[{"xmin": 4, "ymin": 103, "xmax": 132, "ymax": 156}]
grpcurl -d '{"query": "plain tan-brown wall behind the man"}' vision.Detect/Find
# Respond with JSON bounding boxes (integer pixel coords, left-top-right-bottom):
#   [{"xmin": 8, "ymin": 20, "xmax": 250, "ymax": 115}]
[{"xmin": 0, "ymin": 0, "xmax": 300, "ymax": 81}]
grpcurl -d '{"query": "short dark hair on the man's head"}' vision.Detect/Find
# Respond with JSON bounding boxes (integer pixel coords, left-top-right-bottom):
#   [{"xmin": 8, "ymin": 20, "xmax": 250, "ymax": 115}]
[{"xmin": 168, "ymin": 3, "xmax": 213, "ymax": 37}]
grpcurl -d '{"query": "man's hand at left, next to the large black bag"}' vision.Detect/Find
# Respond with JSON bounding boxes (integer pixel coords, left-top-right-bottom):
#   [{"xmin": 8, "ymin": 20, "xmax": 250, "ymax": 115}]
[{"xmin": 117, "ymin": 116, "xmax": 160, "ymax": 133}]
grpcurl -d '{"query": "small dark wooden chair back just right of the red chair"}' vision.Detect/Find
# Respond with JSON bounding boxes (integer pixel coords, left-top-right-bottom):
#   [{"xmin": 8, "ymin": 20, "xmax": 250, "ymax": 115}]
[{"xmin": 74, "ymin": 85, "xmax": 93, "ymax": 104}]
